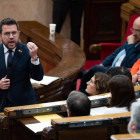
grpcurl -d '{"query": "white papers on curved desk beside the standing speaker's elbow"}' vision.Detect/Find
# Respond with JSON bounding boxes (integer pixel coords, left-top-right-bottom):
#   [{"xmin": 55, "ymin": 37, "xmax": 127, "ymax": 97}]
[{"xmin": 30, "ymin": 76, "xmax": 59, "ymax": 85}]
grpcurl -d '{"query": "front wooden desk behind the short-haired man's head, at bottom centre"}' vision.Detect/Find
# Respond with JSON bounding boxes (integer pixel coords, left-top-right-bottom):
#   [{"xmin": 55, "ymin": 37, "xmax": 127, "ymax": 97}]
[{"xmin": 42, "ymin": 112, "xmax": 130, "ymax": 140}]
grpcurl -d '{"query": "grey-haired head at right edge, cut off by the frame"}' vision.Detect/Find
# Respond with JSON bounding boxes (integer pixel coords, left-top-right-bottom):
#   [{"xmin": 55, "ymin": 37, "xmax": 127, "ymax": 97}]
[{"xmin": 127, "ymin": 101, "xmax": 140, "ymax": 134}]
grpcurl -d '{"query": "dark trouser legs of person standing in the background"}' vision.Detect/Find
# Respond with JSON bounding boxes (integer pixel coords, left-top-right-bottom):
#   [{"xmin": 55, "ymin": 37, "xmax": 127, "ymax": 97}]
[{"xmin": 53, "ymin": 0, "xmax": 84, "ymax": 46}]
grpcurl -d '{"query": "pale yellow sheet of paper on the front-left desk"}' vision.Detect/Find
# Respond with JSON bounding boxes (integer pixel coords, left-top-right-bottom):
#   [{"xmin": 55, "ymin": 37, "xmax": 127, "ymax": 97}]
[{"xmin": 34, "ymin": 114, "xmax": 61, "ymax": 122}]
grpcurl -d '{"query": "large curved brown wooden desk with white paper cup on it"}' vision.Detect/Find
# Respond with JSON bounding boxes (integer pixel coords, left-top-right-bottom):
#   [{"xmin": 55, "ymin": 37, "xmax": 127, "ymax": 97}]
[{"xmin": 18, "ymin": 21, "xmax": 86, "ymax": 103}]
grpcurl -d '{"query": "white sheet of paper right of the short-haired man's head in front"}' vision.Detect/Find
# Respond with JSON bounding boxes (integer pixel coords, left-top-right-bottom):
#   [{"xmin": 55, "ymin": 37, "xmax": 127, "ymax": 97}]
[{"xmin": 90, "ymin": 106, "xmax": 107, "ymax": 116}]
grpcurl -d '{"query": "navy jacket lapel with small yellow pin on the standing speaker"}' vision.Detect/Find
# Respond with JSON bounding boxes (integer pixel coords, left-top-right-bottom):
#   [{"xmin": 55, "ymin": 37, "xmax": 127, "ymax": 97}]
[{"xmin": 11, "ymin": 43, "xmax": 23, "ymax": 73}]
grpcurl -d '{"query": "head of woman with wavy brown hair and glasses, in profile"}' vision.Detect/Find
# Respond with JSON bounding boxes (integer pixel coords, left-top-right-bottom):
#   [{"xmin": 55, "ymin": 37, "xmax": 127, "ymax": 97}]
[{"xmin": 86, "ymin": 72, "xmax": 110, "ymax": 96}]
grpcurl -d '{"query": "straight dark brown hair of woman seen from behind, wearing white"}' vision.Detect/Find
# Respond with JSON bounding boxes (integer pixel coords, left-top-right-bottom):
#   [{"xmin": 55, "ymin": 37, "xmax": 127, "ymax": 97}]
[{"xmin": 108, "ymin": 75, "xmax": 136, "ymax": 109}]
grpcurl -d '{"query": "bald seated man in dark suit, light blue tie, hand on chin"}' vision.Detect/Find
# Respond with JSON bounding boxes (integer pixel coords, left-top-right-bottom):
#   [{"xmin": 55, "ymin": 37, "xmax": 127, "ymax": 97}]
[{"xmin": 79, "ymin": 17, "xmax": 140, "ymax": 95}]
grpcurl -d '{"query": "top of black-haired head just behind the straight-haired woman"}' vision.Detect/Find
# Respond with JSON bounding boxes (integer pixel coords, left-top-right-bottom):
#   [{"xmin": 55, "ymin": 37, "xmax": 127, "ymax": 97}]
[{"xmin": 106, "ymin": 66, "xmax": 132, "ymax": 81}]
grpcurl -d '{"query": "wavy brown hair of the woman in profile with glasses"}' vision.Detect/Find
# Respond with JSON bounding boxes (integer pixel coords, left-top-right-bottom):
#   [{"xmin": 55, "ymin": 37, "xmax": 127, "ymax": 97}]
[{"xmin": 94, "ymin": 72, "xmax": 110, "ymax": 94}]
